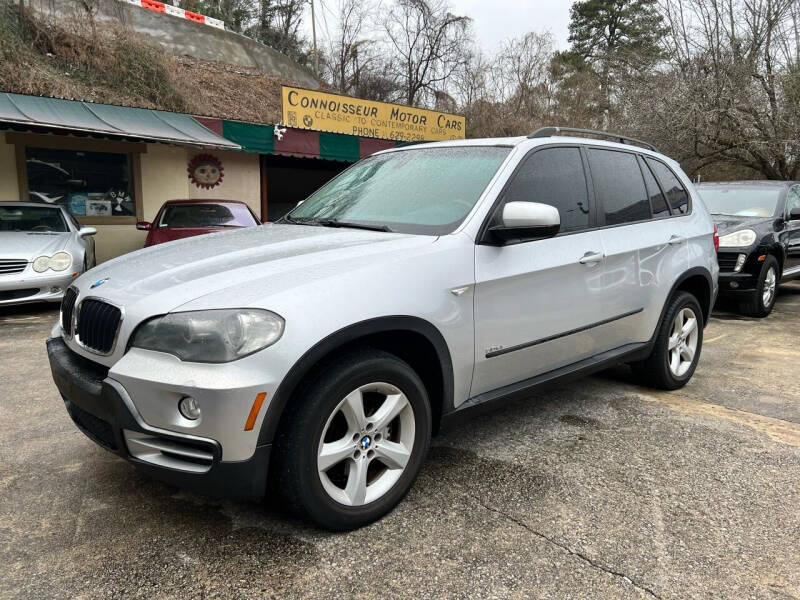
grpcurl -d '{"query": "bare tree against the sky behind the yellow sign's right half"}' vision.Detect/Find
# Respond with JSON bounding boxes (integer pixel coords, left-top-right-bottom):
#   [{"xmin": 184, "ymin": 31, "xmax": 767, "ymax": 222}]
[{"xmin": 383, "ymin": 0, "xmax": 470, "ymax": 106}]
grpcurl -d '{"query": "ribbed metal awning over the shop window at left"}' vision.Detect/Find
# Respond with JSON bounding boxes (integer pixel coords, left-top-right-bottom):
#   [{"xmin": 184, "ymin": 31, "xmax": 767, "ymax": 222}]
[{"xmin": 0, "ymin": 93, "xmax": 241, "ymax": 150}]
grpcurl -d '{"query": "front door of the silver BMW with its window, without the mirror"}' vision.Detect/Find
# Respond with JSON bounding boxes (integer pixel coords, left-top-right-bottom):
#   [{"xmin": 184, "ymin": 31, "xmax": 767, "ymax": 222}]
[{"xmin": 471, "ymin": 146, "xmax": 607, "ymax": 397}]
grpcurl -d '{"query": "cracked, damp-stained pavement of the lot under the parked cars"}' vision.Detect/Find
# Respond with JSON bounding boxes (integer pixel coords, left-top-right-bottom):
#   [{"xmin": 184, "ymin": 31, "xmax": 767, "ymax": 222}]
[{"xmin": 0, "ymin": 284, "xmax": 800, "ymax": 600}]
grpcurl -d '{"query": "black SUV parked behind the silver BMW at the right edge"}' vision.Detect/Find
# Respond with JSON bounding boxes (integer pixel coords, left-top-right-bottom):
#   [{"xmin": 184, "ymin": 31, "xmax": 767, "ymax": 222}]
[{"xmin": 697, "ymin": 181, "xmax": 800, "ymax": 317}]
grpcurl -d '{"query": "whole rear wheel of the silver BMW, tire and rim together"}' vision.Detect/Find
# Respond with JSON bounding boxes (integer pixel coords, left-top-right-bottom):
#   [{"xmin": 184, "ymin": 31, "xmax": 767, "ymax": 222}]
[{"xmin": 631, "ymin": 292, "xmax": 703, "ymax": 390}]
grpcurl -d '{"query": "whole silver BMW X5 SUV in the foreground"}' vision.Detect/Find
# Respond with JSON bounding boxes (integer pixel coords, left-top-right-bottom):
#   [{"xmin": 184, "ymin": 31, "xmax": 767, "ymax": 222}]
[{"xmin": 47, "ymin": 128, "xmax": 718, "ymax": 529}]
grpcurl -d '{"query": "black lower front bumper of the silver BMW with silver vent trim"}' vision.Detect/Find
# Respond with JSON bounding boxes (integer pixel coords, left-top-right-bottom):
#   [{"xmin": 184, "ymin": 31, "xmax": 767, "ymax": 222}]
[{"xmin": 47, "ymin": 338, "xmax": 271, "ymax": 500}]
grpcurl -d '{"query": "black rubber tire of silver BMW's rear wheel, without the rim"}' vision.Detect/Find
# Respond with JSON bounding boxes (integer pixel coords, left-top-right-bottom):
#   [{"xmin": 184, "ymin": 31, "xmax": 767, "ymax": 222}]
[{"xmin": 631, "ymin": 292, "xmax": 703, "ymax": 390}]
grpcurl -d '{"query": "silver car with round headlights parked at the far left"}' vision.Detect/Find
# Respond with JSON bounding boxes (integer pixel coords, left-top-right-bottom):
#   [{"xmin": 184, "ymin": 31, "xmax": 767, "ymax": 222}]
[{"xmin": 0, "ymin": 202, "xmax": 97, "ymax": 306}]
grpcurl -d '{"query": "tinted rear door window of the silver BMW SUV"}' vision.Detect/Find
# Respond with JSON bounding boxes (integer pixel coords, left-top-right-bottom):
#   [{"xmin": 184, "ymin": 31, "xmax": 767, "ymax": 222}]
[{"xmin": 589, "ymin": 149, "xmax": 652, "ymax": 225}]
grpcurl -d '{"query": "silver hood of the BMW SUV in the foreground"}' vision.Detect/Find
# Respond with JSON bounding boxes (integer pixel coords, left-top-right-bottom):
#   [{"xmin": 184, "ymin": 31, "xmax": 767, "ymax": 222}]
[{"xmin": 76, "ymin": 224, "xmax": 437, "ymax": 314}]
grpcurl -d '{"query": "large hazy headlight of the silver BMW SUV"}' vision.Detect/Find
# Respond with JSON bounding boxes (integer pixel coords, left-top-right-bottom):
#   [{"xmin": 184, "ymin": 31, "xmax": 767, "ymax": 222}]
[{"xmin": 131, "ymin": 309, "xmax": 285, "ymax": 363}]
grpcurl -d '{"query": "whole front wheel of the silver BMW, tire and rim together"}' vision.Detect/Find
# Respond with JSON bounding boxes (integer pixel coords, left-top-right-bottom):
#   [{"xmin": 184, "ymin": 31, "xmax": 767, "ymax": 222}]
[{"xmin": 274, "ymin": 350, "xmax": 432, "ymax": 531}]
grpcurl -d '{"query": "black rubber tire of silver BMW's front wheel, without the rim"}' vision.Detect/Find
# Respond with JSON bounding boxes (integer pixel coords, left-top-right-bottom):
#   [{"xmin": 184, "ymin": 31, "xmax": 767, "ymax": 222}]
[{"xmin": 271, "ymin": 349, "xmax": 432, "ymax": 531}]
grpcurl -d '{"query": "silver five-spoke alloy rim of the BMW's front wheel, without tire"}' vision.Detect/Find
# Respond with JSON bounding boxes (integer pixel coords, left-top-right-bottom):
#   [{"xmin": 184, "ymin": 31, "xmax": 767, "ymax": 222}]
[{"xmin": 317, "ymin": 382, "xmax": 416, "ymax": 506}]
